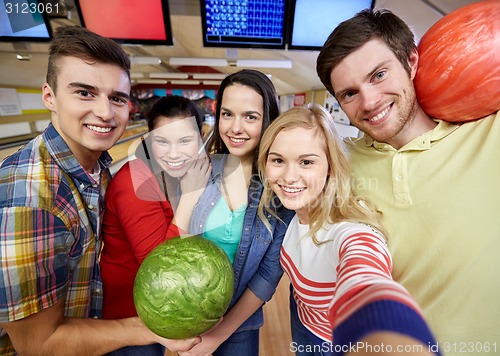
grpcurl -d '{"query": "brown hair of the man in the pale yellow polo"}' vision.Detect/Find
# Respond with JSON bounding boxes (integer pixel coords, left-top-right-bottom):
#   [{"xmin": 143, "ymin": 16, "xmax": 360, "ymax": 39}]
[{"xmin": 316, "ymin": 10, "xmax": 416, "ymax": 96}]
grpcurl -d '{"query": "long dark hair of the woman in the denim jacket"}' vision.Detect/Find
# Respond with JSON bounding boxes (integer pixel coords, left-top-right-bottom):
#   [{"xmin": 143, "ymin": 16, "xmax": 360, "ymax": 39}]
[{"xmin": 208, "ymin": 69, "xmax": 280, "ymax": 173}]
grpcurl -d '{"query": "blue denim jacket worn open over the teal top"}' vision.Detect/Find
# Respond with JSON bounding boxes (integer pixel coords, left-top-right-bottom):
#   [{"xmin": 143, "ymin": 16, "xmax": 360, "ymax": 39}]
[{"xmin": 189, "ymin": 155, "xmax": 294, "ymax": 332}]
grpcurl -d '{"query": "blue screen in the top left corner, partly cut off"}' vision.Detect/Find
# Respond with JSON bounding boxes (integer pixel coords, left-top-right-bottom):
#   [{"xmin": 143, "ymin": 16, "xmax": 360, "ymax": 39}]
[{"xmin": 0, "ymin": 0, "xmax": 52, "ymax": 42}]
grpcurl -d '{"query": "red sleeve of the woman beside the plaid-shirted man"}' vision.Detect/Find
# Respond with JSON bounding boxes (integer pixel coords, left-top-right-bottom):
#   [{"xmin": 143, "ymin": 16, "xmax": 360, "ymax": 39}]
[{"xmin": 105, "ymin": 160, "xmax": 179, "ymax": 263}]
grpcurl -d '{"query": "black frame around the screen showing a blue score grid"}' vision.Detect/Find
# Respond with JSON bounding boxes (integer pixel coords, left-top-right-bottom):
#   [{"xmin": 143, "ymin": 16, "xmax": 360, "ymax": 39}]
[{"xmin": 200, "ymin": 0, "xmax": 290, "ymax": 49}]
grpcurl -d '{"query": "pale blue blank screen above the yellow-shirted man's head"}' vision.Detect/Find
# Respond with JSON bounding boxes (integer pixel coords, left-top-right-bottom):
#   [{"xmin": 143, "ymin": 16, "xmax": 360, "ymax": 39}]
[{"xmin": 288, "ymin": 0, "xmax": 375, "ymax": 51}]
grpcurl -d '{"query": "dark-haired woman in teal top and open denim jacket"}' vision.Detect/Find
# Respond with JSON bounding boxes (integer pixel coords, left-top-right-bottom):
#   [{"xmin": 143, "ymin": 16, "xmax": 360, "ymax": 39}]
[{"xmin": 189, "ymin": 70, "xmax": 291, "ymax": 356}]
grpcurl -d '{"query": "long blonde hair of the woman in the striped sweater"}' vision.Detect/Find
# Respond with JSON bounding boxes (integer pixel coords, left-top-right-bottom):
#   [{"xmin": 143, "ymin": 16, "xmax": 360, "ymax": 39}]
[{"xmin": 257, "ymin": 104, "xmax": 387, "ymax": 245}]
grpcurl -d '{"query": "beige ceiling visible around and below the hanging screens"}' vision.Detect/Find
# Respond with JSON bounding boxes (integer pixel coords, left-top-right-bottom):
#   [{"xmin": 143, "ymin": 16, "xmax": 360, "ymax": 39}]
[{"xmin": 0, "ymin": 0, "xmax": 477, "ymax": 95}]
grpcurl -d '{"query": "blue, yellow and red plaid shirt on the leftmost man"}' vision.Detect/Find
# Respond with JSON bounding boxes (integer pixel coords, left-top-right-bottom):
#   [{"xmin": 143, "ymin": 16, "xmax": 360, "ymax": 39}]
[{"xmin": 0, "ymin": 125, "xmax": 111, "ymax": 355}]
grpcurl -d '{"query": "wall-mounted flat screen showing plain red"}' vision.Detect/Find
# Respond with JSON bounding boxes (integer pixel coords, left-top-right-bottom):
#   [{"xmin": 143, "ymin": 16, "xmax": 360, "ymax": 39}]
[{"xmin": 75, "ymin": 0, "xmax": 173, "ymax": 46}]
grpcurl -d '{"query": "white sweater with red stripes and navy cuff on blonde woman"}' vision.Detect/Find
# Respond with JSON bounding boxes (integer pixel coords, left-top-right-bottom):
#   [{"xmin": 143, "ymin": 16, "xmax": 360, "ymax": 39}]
[{"xmin": 280, "ymin": 216, "xmax": 440, "ymax": 352}]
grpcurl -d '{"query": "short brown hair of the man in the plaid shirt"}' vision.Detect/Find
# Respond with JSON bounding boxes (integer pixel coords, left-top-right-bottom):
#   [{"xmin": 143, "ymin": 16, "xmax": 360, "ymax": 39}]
[{"xmin": 46, "ymin": 26, "xmax": 130, "ymax": 93}]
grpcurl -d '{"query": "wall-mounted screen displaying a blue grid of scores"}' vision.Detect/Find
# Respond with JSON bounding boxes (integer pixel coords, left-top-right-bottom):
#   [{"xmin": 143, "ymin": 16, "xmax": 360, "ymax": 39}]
[{"xmin": 200, "ymin": 0, "xmax": 288, "ymax": 49}]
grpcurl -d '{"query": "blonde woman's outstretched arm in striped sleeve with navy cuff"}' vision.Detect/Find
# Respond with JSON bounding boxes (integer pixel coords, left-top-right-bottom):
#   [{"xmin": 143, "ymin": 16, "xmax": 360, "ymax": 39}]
[{"xmin": 330, "ymin": 229, "xmax": 435, "ymax": 355}]
